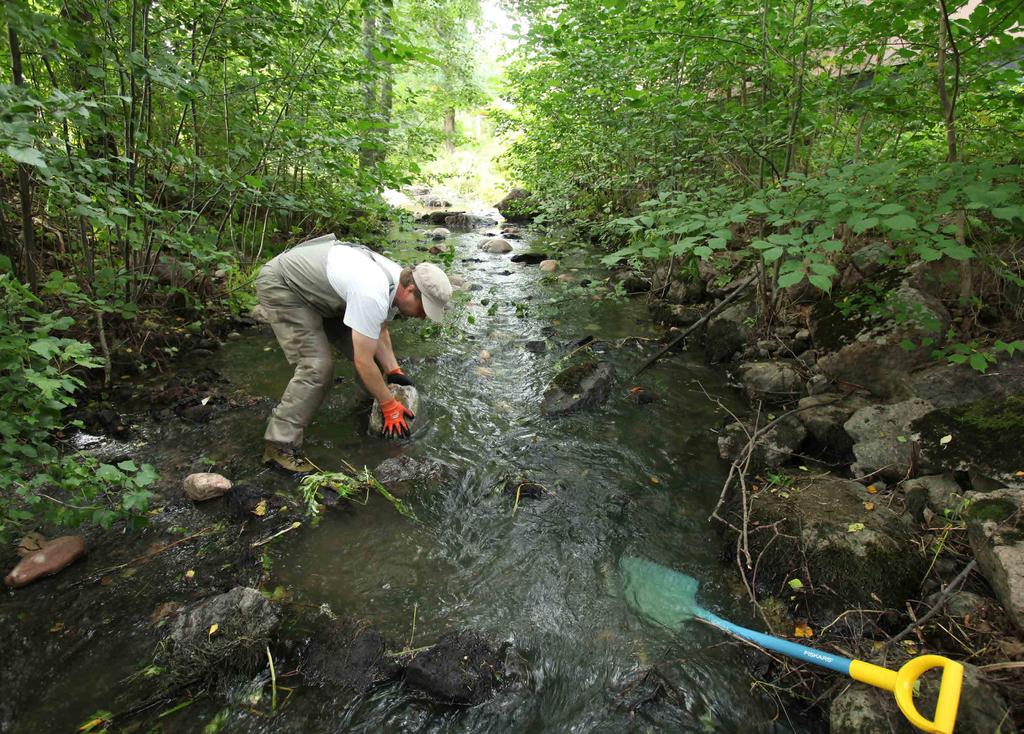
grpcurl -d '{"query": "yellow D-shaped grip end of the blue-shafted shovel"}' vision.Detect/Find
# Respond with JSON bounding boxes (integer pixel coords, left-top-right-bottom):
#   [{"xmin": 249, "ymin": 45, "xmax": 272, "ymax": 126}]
[{"xmin": 850, "ymin": 655, "xmax": 964, "ymax": 734}]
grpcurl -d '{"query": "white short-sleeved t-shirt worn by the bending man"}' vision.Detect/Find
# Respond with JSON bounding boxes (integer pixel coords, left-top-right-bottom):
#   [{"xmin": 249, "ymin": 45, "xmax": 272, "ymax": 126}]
[{"xmin": 327, "ymin": 245, "xmax": 401, "ymax": 339}]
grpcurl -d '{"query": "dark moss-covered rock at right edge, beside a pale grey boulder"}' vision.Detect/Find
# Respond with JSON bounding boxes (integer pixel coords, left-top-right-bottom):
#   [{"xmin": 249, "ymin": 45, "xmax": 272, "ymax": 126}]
[{"xmin": 912, "ymin": 396, "xmax": 1024, "ymax": 484}]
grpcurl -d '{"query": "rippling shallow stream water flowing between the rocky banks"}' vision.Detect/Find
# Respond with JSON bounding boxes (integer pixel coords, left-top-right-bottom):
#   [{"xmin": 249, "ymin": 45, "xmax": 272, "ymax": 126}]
[{"xmin": 9, "ymin": 219, "xmax": 792, "ymax": 732}]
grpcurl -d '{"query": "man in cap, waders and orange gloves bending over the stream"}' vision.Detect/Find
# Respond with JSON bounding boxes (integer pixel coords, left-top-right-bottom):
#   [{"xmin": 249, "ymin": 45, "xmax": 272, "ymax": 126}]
[{"xmin": 256, "ymin": 234, "xmax": 452, "ymax": 474}]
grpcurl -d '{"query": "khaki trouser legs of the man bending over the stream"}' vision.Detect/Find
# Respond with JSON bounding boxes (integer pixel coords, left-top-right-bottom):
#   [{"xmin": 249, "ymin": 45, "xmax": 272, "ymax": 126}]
[{"xmin": 256, "ymin": 258, "xmax": 352, "ymax": 448}]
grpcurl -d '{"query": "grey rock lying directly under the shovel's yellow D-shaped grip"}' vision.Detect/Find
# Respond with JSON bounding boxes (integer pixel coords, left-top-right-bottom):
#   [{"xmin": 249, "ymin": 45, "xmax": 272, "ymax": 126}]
[{"xmin": 828, "ymin": 663, "xmax": 1013, "ymax": 734}]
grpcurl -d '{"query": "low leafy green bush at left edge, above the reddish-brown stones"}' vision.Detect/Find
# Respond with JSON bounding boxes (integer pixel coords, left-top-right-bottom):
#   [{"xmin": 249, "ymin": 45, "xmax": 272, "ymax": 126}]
[{"xmin": 0, "ymin": 274, "xmax": 158, "ymax": 542}]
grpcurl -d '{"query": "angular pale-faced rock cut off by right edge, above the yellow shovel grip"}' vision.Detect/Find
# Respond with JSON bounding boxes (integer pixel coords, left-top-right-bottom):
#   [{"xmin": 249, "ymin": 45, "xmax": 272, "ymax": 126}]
[{"xmin": 967, "ymin": 487, "xmax": 1024, "ymax": 630}]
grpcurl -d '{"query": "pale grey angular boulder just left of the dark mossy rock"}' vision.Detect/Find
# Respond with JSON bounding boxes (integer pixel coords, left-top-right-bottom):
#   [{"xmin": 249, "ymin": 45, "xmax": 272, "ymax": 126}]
[{"xmin": 844, "ymin": 398, "xmax": 933, "ymax": 479}]
